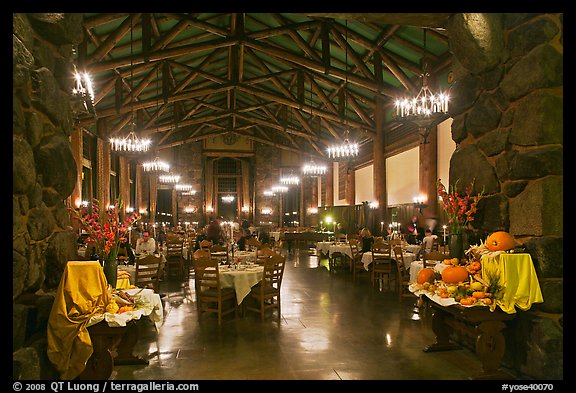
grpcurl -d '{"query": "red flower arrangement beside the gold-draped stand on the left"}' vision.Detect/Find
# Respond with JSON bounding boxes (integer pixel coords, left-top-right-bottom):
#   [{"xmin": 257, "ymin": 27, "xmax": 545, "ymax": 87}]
[{"xmin": 69, "ymin": 199, "xmax": 141, "ymax": 261}]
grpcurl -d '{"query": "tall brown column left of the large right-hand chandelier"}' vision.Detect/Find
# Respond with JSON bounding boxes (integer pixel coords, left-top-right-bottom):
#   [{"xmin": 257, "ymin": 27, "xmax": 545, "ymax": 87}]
[{"xmin": 373, "ymin": 96, "xmax": 390, "ymax": 234}]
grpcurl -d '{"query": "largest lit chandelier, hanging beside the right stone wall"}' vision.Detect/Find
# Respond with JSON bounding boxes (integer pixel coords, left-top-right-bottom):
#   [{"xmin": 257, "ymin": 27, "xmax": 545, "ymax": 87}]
[{"xmin": 396, "ymin": 29, "xmax": 449, "ymax": 129}]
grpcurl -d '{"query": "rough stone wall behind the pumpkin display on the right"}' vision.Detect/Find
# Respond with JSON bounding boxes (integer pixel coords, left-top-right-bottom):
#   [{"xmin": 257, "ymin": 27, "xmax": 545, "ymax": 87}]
[{"xmin": 447, "ymin": 14, "xmax": 563, "ymax": 379}]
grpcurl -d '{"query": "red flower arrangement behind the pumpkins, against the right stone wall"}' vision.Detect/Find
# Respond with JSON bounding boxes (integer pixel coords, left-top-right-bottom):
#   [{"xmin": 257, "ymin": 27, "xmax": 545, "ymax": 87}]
[{"xmin": 438, "ymin": 179, "xmax": 484, "ymax": 234}]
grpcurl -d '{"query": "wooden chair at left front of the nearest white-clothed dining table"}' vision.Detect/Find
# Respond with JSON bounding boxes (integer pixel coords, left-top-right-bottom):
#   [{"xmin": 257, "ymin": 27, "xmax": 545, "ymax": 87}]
[{"xmin": 193, "ymin": 256, "xmax": 238, "ymax": 326}]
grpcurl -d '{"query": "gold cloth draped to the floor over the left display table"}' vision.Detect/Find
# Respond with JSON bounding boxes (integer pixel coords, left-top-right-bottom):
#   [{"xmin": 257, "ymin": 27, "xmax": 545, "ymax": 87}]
[{"xmin": 48, "ymin": 261, "xmax": 110, "ymax": 380}]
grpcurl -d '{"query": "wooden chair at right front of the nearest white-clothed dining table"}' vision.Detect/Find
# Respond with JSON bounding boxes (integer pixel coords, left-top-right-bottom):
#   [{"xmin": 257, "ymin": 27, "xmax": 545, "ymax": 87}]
[{"xmin": 246, "ymin": 254, "xmax": 286, "ymax": 325}]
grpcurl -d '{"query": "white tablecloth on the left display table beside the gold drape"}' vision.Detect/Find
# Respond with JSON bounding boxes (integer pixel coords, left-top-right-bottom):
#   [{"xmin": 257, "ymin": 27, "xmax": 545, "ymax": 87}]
[{"xmin": 88, "ymin": 288, "xmax": 164, "ymax": 329}]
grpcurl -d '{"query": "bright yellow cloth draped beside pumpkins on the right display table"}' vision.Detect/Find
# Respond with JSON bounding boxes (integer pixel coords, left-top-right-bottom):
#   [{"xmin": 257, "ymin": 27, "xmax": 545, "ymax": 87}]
[{"xmin": 482, "ymin": 253, "xmax": 544, "ymax": 314}]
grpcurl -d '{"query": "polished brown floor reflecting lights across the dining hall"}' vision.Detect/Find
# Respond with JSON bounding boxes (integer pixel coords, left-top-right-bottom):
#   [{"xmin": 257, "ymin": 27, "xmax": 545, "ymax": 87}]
[{"xmin": 111, "ymin": 250, "xmax": 508, "ymax": 380}]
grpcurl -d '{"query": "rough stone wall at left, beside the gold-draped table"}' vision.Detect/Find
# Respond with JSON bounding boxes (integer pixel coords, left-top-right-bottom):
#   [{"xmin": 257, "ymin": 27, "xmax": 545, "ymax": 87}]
[{"xmin": 12, "ymin": 14, "xmax": 82, "ymax": 379}]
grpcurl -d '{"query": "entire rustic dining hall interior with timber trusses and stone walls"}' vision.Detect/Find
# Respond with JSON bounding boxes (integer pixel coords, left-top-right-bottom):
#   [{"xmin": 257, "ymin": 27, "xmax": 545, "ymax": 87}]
[{"xmin": 12, "ymin": 13, "xmax": 565, "ymax": 387}]
